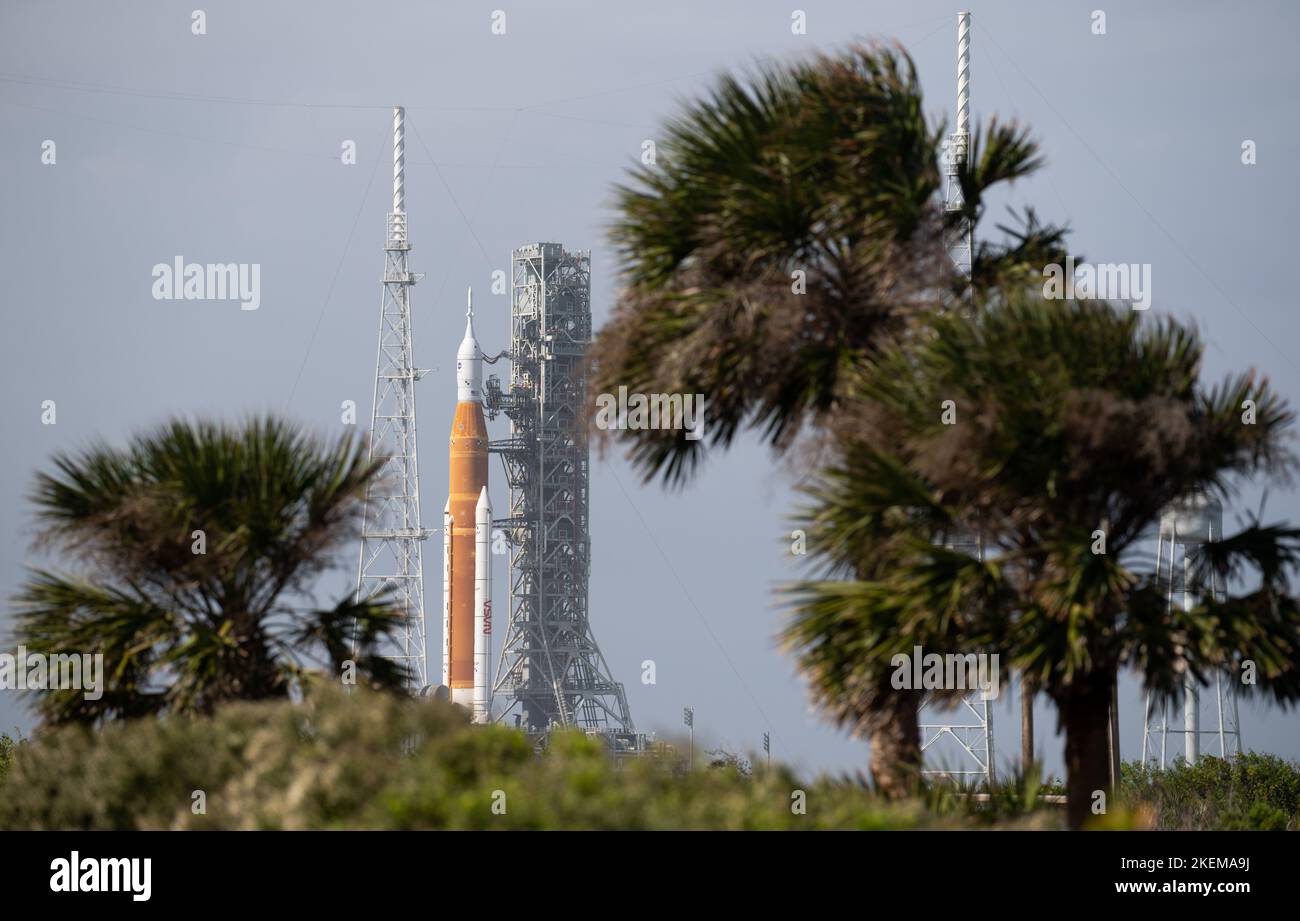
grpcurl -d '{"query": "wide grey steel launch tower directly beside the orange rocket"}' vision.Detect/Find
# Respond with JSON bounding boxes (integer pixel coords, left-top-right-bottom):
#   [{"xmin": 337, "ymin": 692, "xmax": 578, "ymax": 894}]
[{"xmin": 485, "ymin": 243, "xmax": 634, "ymax": 745}]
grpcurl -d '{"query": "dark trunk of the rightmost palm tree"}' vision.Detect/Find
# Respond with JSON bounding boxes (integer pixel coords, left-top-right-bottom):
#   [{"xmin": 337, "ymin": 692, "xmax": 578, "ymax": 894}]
[{"xmin": 1060, "ymin": 674, "xmax": 1112, "ymax": 830}]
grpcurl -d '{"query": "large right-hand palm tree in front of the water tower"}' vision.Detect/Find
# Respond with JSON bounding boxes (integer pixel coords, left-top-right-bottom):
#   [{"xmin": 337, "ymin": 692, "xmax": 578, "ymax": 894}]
[{"xmin": 787, "ymin": 293, "xmax": 1300, "ymax": 827}]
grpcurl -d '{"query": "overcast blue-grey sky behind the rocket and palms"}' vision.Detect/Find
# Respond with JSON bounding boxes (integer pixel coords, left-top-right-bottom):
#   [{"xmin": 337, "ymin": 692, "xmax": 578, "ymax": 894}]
[{"xmin": 0, "ymin": 0, "xmax": 1300, "ymax": 771}]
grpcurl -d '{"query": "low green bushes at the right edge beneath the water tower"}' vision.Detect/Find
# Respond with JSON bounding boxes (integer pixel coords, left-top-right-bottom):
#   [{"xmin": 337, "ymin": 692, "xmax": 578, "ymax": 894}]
[{"xmin": 1119, "ymin": 752, "xmax": 1300, "ymax": 831}]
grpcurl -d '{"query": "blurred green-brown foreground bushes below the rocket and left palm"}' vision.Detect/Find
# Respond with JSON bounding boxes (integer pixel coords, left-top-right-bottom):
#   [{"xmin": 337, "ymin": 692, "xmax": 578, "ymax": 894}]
[{"xmin": 0, "ymin": 691, "xmax": 1058, "ymax": 829}]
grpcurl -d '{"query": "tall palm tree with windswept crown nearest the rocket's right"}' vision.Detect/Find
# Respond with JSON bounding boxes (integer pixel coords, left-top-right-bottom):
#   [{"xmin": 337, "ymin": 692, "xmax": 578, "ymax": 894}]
[{"xmin": 593, "ymin": 46, "xmax": 1065, "ymax": 791}]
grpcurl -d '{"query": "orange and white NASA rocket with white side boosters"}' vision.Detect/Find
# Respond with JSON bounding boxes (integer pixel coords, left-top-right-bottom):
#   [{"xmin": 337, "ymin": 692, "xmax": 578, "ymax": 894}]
[{"xmin": 442, "ymin": 291, "xmax": 491, "ymax": 722}]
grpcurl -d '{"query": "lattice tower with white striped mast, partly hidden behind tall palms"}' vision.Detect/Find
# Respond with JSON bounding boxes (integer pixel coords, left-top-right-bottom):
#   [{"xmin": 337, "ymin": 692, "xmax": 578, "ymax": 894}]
[{"xmin": 920, "ymin": 13, "xmax": 996, "ymax": 786}]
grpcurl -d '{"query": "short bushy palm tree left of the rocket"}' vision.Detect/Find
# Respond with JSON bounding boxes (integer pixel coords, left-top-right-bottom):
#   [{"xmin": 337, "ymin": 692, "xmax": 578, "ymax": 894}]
[{"xmin": 16, "ymin": 418, "xmax": 404, "ymax": 723}]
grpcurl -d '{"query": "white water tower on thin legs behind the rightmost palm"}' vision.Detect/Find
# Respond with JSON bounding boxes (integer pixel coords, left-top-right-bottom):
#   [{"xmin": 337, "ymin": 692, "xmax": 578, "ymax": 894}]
[{"xmin": 1141, "ymin": 496, "xmax": 1242, "ymax": 769}]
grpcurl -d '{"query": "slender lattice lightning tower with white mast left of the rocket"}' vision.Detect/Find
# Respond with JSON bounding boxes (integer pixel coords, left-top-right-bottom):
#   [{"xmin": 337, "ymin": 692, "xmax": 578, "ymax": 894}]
[{"xmin": 356, "ymin": 107, "xmax": 433, "ymax": 692}]
